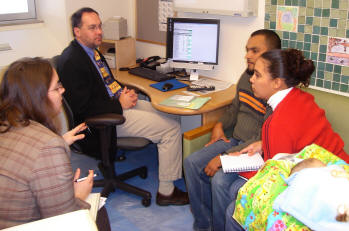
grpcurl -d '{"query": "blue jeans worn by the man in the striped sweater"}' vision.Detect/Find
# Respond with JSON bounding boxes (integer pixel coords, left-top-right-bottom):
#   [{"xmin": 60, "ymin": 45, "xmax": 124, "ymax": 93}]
[{"xmin": 184, "ymin": 139, "xmax": 241, "ymax": 231}]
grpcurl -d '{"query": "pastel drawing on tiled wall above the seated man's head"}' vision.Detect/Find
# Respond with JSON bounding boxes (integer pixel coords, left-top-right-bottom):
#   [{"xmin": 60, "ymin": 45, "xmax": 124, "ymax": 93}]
[{"xmin": 276, "ymin": 6, "xmax": 298, "ymax": 32}]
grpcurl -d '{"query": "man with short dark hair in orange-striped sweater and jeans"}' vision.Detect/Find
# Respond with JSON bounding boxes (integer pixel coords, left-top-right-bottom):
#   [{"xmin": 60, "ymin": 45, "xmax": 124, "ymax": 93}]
[{"xmin": 184, "ymin": 29, "xmax": 281, "ymax": 231}]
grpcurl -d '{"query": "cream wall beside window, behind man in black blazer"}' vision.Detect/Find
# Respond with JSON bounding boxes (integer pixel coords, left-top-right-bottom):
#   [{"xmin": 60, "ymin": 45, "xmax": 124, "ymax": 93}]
[{"xmin": 0, "ymin": 0, "xmax": 134, "ymax": 69}]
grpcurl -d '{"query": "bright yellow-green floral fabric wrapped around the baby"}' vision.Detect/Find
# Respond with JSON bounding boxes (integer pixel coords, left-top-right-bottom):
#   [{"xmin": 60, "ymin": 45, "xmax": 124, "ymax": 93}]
[{"xmin": 233, "ymin": 144, "xmax": 349, "ymax": 231}]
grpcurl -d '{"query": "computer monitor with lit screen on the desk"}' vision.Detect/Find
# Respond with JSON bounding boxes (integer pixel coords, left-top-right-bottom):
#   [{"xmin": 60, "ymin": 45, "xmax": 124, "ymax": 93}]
[{"xmin": 166, "ymin": 18, "xmax": 220, "ymax": 80}]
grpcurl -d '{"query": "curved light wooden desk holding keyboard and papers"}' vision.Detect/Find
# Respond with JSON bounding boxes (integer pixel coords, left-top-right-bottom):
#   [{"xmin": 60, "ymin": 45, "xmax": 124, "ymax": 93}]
[{"xmin": 113, "ymin": 70, "xmax": 235, "ymax": 125}]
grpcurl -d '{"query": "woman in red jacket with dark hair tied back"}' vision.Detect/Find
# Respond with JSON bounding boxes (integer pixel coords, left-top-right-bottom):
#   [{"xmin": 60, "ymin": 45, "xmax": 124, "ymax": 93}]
[{"xmin": 241, "ymin": 49, "xmax": 349, "ymax": 162}]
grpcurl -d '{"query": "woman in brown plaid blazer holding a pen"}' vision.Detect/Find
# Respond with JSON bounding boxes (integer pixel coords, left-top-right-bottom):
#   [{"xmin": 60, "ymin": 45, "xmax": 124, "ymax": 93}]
[{"xmin": 0, "ymin": 58, "xmax": 93, "ymax": 229}]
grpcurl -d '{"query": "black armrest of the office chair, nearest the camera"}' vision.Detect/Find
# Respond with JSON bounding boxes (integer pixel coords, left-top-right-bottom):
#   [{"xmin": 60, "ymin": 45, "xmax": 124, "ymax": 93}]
[{"xmin": 85, "ymin": 113, "xmax": 125, "ymax": 126}]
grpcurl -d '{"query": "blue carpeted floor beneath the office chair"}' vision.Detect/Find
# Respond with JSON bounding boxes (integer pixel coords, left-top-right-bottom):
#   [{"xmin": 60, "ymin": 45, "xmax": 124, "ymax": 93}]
[{"xmin": 72, "ymin": 144, "xmax": 193, "ymax": 231}]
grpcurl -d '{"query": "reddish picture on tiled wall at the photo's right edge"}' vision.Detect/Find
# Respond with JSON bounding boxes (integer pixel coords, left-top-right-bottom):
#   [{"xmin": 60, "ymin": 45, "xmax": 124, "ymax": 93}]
[{"xmin": 326, "ymin": 37, "xmax": 349, "ymax": 66}]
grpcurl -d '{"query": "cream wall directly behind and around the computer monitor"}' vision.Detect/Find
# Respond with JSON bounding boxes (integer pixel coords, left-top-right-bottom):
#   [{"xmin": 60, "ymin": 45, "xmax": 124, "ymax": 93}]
[{"xmin": 136, "ymin": 0, "xmax": 265, "ymax": 83}]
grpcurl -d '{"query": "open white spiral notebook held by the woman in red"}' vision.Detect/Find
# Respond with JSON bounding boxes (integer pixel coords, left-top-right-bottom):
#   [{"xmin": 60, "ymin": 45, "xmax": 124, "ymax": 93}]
[{"xmin": 221, "ymin": 153, "xmax": 264, "ymax": 173}]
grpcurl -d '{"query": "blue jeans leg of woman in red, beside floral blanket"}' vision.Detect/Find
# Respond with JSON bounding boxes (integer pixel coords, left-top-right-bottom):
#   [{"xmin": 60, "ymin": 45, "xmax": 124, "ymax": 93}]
[{"xmin": 225, "ymin": 178, "xmax": 246, "ymax": 231}]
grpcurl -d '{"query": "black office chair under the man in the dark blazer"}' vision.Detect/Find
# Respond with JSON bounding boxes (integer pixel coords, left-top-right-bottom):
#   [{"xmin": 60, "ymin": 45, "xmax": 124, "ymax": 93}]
[{"xmin": 63, "ymin": 98, "xmax": 151, "ymax": 207}]
